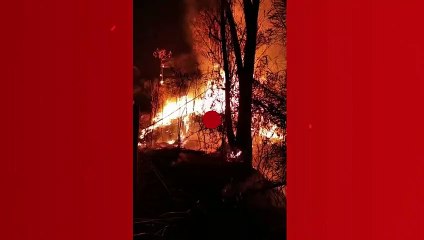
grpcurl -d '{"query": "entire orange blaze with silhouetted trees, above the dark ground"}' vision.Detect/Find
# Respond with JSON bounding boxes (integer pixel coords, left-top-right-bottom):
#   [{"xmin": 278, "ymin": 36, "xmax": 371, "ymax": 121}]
[{"xmin": 141, "ymin": 0, "xmax": 287, "ymax": 188}]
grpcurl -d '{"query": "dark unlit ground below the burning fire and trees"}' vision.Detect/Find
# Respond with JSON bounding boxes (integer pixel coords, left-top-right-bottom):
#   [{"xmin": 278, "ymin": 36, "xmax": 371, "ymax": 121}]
[{"xmin": 134, "ymin": 148, "xmax": 286, "ymax": 240}]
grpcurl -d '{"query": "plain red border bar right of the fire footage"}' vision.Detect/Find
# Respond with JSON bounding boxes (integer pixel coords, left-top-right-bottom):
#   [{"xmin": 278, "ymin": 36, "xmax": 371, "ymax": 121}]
[{"xmin": 287, "ymin": 0, "xmax": 424, "ymax": 240}]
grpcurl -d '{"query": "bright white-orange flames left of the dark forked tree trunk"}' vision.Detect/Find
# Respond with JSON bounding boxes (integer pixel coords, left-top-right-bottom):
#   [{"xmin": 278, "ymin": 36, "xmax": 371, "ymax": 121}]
[{"xmin": 140, "ymin": 45, "xmax": 223, "ymax": 152}]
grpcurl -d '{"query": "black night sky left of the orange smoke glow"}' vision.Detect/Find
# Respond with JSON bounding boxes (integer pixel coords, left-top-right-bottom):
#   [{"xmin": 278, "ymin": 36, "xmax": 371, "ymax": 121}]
[{"xmin": 133, "ymin": 0, "xmax": 191, "ymax": 78}]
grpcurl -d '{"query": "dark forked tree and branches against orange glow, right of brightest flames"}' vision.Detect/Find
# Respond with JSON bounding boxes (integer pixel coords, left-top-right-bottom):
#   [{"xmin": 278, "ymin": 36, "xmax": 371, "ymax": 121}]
[{"xmin": 192, "ymin": 0, "xmax": 287, "ymax": 184}]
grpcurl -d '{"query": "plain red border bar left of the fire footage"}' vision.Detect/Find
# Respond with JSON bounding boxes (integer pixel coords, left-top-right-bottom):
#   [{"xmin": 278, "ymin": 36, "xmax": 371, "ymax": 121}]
[{"xmin": 0, "ymin": 0, "xmax": 132, "ymax": 240}]
